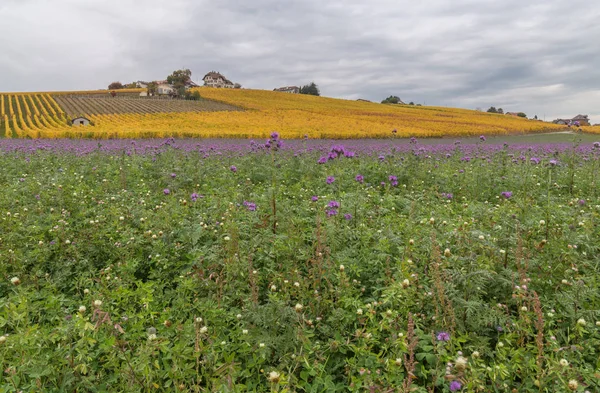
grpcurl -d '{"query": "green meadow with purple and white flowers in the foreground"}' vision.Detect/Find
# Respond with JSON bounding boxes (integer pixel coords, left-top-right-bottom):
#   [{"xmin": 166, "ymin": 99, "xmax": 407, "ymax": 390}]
[{"xmin": 0, "ymin": 133, "xmax": 600, "ymax": 392}]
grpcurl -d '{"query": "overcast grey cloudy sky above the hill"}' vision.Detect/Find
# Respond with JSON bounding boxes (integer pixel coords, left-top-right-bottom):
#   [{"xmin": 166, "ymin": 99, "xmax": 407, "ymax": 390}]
[{"xmin": 0, "ymin": 0, "xmax": 600, "ymax": 123}]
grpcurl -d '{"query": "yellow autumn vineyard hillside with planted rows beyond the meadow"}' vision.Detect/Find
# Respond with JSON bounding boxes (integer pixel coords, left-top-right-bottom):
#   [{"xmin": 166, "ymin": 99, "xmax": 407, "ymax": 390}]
[{"xmin": 0, "ymin": 88, "xmax": 584, "ymax": 139}]
